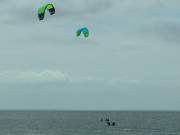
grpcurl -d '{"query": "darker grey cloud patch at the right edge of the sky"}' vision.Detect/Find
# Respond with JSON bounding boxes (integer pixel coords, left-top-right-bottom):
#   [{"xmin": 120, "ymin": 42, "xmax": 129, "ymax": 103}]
[{"xmin": 141, "ymin": 17, "xmax": 180, "ymax": 44}]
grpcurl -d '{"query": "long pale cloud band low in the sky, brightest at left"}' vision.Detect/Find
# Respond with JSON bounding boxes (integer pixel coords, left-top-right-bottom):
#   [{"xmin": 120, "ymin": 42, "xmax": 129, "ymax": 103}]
[{"xmin": 0, "ymin": 69, "xmax": 142, "ymax": 86}]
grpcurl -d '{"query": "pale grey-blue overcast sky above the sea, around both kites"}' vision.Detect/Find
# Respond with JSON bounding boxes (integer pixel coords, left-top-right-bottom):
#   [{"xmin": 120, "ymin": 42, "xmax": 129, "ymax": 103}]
[{"xmin": 0, "ymin": 0, "xmax": 180, "ymax": 110}]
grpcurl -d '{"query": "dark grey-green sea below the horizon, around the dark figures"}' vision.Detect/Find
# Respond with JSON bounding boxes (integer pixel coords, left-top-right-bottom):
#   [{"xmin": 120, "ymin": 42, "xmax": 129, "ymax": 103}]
[{"xmin": 0, "ymin": 111, "xmax": 180, "ymax": 135}]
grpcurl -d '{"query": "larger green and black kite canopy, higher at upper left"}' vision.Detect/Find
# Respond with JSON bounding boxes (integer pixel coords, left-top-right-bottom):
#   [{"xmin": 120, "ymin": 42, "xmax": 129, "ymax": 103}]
[{"xmin": 38, "ymin": 3, "xmax": 55, "ymax": 20}]
